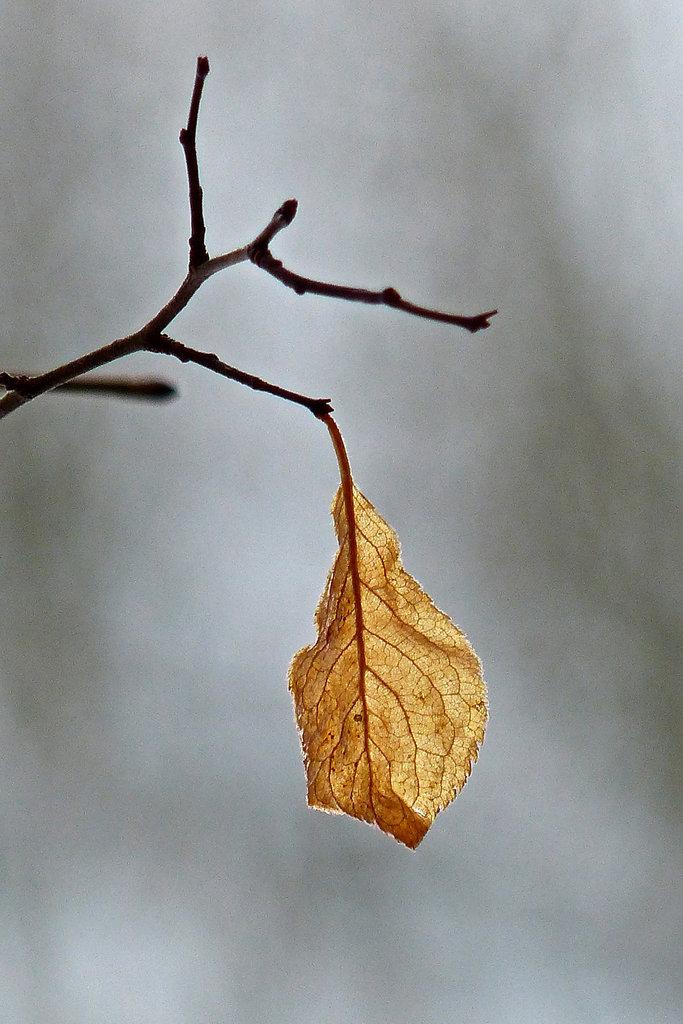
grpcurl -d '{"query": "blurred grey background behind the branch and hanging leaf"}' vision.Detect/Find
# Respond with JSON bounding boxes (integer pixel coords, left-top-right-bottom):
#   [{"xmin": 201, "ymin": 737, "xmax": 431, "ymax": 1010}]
[{"xmin": 0, "ymin": 0, "xmax": 683, "ymax": 1024}]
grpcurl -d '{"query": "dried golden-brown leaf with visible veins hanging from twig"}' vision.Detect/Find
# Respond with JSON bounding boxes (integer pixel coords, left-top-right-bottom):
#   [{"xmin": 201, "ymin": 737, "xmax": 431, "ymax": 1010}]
[{"xmin": 290, "ymin": 418, "xmax": 486, "ymax": 848}]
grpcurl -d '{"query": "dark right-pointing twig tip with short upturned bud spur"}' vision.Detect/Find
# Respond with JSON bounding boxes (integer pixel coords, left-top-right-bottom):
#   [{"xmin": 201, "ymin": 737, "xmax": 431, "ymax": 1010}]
[{"xmin": 249, "ymin": 205, "xmax": 498, "ymax": 334}]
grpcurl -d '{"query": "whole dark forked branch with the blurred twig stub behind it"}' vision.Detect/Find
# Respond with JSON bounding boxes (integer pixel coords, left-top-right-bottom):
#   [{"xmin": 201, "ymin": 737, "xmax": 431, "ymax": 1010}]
[{"xmin": 0, "ymin": 57, "xmax": 497, "ymax": 419}]
